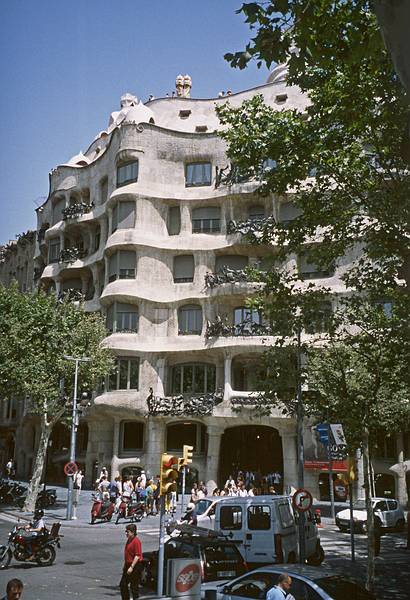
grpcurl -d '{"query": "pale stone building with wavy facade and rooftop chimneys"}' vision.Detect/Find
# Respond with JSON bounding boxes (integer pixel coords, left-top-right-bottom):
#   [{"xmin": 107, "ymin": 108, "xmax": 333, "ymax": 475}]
[{"xmin": 7, "ymin": 66, "xmax": 406, "ymax": 496}]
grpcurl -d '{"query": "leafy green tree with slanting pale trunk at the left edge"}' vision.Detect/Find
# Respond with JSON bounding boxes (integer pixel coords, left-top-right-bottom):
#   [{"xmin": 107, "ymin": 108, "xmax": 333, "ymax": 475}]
[{"xmin": 0, "ymin": 285, "xmax": 113, "ymax": 510}]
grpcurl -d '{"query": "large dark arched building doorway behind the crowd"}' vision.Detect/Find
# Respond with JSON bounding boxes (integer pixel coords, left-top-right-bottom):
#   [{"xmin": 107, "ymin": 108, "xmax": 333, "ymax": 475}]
[{"xmin": 219, "ymin": 425, "xmax": 283, "ymax": 485}]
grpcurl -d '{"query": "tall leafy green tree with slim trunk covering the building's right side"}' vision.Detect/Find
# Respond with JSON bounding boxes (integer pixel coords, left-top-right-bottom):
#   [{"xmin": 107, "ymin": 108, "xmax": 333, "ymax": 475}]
[{"xmin": 218, "ymin": 0, "xmax": 410, "ymax": 588}]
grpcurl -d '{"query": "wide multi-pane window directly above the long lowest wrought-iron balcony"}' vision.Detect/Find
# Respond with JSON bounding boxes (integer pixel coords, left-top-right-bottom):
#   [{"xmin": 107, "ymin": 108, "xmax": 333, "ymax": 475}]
[{"xmin": 171, "ymin": 364, "xmax": 215, "ymax": 394}]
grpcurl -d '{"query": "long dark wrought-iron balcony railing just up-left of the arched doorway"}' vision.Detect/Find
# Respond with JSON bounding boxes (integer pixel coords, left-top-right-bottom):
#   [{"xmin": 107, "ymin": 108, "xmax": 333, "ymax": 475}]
[{"xmin": 147, "ymin": 390, "xmax": 223, "ymax": 417}]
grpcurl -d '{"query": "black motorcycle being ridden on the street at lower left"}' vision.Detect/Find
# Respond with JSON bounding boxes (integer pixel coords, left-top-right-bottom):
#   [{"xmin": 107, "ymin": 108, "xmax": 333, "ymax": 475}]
[{"xmin": 0, "ymin": 523, "xmax": 61, "ymax": 569}]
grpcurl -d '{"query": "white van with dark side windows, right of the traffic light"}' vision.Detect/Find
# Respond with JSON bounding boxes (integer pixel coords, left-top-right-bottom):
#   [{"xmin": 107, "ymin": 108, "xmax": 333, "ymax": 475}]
[{"xmin": 196, "ymin": 496, "xmax": 324, "ymax": 564}]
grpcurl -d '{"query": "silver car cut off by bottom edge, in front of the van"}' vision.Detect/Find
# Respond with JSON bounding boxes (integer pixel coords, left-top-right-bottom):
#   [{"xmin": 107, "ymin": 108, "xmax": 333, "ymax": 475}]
[{"xmin": 201, "ymin": 565, "xmax": 376, "ymax": 600}]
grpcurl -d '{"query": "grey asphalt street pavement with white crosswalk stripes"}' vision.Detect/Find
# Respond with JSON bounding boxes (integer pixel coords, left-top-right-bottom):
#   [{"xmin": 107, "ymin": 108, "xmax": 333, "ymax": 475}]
[{"xmin": 0, "ymin": 488, "xmax": 410, "ymax": 600}]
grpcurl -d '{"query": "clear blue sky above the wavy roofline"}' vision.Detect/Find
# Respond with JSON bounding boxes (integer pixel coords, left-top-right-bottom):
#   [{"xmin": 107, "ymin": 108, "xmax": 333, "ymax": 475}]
[{"xmin": 0, "ymin": 0, "xmax": 268, "ymax": 244}]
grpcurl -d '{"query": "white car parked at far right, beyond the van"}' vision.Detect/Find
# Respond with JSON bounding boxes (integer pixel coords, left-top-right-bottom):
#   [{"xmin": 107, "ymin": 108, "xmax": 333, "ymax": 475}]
[{"xmin": 336, "ymin": 498, "xmax": 405, "ymax": 533}]
